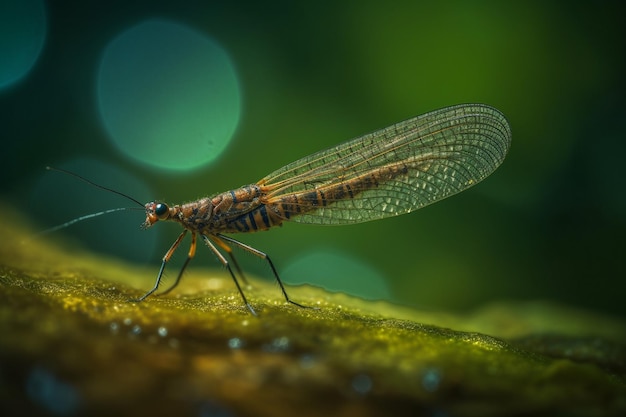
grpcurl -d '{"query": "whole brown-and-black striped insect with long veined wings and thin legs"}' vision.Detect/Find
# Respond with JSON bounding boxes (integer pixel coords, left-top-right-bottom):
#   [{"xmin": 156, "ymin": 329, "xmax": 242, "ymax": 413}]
[{"xmin": 47, "ymin": 104, "xmax": 511, "ymax": 315}]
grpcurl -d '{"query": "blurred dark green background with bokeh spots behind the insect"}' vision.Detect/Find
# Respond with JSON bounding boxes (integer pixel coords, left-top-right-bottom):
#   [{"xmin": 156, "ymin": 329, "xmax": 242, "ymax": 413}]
[{"xmin": 0, "ymin": 0, "xmax": 626, "ymax": 316}]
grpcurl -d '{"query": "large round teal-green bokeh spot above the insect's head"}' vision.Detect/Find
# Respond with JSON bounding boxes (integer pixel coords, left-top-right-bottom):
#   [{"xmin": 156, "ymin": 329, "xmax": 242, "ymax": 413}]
[{"xmin": 97, "ymin": 20, "xmax": 241, "ymax": 171}]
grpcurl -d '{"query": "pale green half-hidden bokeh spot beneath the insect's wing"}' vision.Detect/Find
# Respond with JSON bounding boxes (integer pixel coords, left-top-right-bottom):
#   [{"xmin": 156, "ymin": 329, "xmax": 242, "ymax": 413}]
[{"xmin": 281, "ymin": 249, "xmax": 391, "ymax": 300}]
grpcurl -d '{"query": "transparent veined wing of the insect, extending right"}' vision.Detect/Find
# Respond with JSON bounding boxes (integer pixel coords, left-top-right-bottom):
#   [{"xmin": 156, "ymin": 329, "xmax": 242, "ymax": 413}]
[{"xmin": 258, "ymin": 104, "xmax": 511, "ymax": 225}]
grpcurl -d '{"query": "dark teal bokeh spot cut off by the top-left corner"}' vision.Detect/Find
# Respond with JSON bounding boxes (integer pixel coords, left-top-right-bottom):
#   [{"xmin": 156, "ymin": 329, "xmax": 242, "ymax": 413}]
[{"xmin": 0, "ymin": 0, "xmax": 46, "ymax": 90}]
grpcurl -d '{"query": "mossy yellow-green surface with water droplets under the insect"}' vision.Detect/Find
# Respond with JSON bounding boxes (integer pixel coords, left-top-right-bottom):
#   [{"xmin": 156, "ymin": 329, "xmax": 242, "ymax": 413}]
[{"xmin": 0, "ymin": 203, "xmax": 626, "ymax": 416}]
